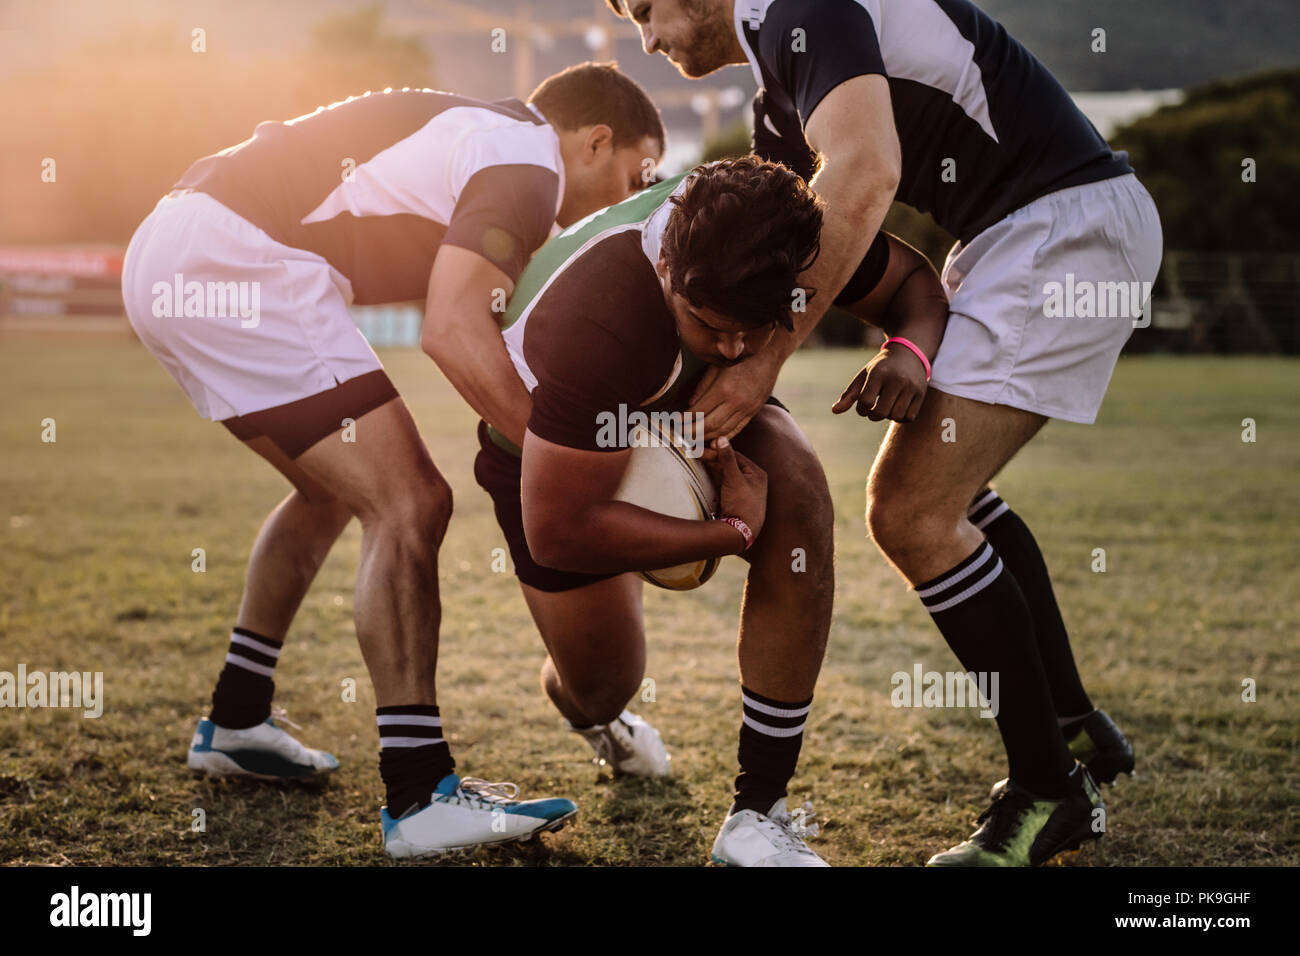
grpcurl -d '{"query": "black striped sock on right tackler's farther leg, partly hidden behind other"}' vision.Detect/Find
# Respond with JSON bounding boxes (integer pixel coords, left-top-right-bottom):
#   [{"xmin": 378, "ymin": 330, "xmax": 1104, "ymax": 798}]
[{"xmin": 969, "ymin": 488, "xmax": 1093, "ymax": 717}]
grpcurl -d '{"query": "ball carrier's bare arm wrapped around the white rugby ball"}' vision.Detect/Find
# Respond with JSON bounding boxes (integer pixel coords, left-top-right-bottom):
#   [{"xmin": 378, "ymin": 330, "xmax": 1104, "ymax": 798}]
[{"xmin": 521, "ymin": 431, "xmax": 767, "ymax": 574}]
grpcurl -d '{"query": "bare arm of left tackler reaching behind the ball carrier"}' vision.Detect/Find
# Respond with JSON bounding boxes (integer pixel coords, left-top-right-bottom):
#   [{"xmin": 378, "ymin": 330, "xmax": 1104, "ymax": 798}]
[{"xmin": 420, "ymin": 243, "xmax": 532, "ymax": 445}]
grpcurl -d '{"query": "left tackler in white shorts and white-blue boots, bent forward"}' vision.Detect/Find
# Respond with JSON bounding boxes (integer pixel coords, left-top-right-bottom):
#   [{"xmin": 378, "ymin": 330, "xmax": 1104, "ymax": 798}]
[{"xmin": 122, "ymin": 64, "xmax": 664, "ymax": 856}]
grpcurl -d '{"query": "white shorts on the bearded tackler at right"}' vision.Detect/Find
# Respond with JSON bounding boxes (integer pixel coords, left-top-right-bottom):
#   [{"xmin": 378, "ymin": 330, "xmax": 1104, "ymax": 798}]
[{"xmin": 931, "ymin": 174, "xmax": 1164, "ymax": 424}]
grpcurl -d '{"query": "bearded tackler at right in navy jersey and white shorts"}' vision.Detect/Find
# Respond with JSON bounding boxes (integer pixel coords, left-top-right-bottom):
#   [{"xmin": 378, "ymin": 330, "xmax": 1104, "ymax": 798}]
[{"xmin": 607, "ymin": 0, "xmax": 1162, "ymax": 866}]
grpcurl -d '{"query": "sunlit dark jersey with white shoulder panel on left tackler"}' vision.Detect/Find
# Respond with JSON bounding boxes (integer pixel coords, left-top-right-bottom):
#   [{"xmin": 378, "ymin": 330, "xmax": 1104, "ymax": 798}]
[{"xmin": 177, "ymin": 90, "xmax": 563, "ymax": 303}]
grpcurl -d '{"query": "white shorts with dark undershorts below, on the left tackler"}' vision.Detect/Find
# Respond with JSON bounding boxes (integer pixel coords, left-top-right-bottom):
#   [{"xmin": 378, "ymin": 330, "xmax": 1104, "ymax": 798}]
[{"xmin": 122, "ymin": 191, "xmax": 382, "ymax": 420}]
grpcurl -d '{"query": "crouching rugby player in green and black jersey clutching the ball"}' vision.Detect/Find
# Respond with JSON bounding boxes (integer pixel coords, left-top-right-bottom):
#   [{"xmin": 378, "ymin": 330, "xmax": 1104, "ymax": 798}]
[{"xmin": 447, "ymin": 157, "xmax": 946, "ymax": 866}]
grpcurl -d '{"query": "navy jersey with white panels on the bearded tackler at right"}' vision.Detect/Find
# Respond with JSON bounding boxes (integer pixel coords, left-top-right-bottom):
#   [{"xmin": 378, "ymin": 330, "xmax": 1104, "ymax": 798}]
[{"xmin": 736, "ymin": 0, "xmax": 1132, "ymax": 241}]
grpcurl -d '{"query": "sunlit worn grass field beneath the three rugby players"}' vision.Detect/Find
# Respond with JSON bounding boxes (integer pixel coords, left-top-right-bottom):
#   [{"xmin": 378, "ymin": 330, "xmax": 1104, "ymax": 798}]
[{"xmin": 0, "ymin": 334, "xmax": 1300, "ymax": 865}]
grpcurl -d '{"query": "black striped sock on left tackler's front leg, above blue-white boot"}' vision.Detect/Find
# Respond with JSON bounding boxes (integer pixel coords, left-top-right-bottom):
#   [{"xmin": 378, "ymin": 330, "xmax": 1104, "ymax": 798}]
[{"xmin": 374, "ymin": 704, "xmax": 456, "ymax": 818}]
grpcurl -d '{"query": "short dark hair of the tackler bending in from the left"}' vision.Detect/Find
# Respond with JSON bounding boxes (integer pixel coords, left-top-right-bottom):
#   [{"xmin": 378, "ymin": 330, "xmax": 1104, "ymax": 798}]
[{"xmin": 528, "ymin": 62, "xmax": 668, "ymax": 150}]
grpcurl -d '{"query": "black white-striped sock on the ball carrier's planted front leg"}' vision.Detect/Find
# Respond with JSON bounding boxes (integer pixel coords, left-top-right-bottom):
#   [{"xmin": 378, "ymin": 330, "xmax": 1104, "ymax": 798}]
[{"xmin": 731, "ymin": 687, "xmax": 813, "ymax": 814}]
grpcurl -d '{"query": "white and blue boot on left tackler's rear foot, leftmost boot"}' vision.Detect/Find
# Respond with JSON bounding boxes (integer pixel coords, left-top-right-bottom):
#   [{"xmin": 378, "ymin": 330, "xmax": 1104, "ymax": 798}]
[{"xmin": 186, "ymin": 710, "xmax": 338, "ymax": 780}]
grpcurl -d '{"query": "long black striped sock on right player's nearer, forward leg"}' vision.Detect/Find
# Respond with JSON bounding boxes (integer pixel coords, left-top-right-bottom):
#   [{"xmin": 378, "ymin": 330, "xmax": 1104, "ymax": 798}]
[{"xmin": 917, "ymin": 542, "xmax": 1074, "ymax": 797}]
